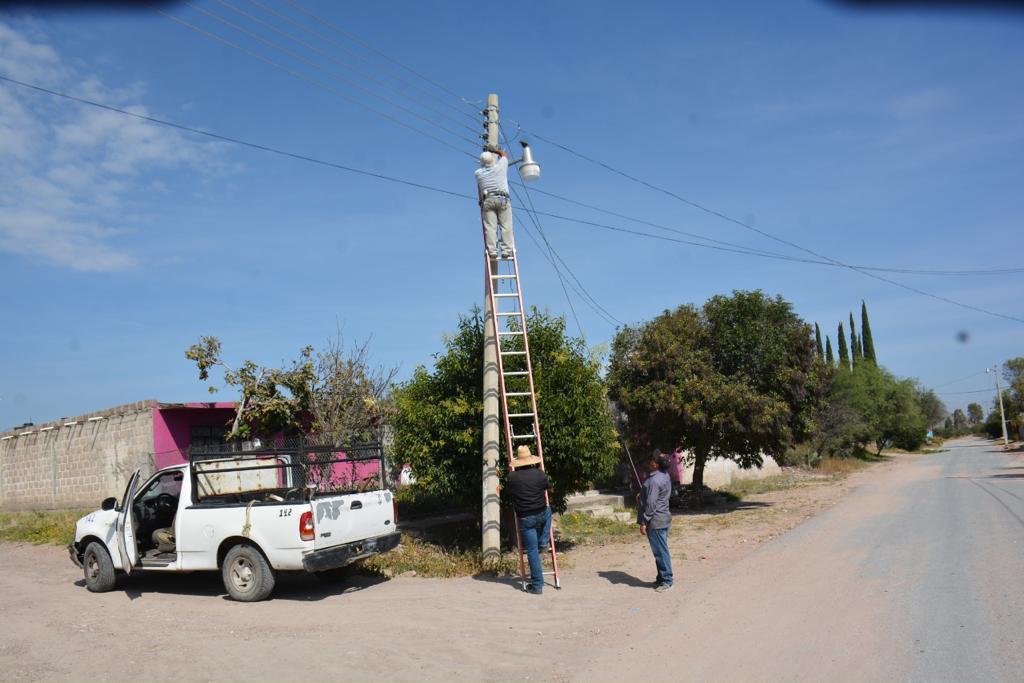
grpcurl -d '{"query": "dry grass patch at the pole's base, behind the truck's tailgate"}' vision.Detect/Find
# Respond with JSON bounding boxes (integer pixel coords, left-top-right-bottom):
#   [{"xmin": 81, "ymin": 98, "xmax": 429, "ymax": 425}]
[{"xmin": 359, "ymin": 533, "xmax": 519, "ymax": 579}]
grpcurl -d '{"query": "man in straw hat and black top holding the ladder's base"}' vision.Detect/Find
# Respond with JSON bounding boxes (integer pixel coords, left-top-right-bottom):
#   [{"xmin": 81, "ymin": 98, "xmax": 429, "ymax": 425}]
[{"xmin": 507, "ymin": 445, "xmax": 551, "ymax": 595}]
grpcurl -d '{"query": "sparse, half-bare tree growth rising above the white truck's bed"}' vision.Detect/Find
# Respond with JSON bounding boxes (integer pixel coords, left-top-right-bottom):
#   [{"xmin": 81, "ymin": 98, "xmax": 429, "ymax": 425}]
[{"xmin": 185, "ymin": 334, "xmax": 396, "ymax": 443}]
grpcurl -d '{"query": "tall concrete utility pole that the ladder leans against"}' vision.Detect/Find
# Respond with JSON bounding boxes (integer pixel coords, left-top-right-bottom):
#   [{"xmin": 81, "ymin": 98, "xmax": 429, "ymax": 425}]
[{"xmin": 480, "ymin": 94, "xmax": 502, "ymax": 561}]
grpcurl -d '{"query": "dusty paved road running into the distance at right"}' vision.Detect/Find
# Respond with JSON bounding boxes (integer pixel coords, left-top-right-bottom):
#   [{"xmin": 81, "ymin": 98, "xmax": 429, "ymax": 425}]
[{"xmin": 579, "ymin": 439, "xmax": 1024, "ymax": 681}]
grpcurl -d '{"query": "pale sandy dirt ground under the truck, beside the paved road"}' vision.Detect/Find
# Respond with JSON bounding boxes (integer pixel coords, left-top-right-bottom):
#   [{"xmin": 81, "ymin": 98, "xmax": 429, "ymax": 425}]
[{"xmin": 0, "ymin": 457, "xmax": 892, "ymax": 683}]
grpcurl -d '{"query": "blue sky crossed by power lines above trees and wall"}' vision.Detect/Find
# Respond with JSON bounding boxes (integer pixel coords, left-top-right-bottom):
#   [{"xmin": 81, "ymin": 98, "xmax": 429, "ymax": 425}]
[{"xmin": 0, "ymin": 0, "xmax": 1024, "ymax": 428}]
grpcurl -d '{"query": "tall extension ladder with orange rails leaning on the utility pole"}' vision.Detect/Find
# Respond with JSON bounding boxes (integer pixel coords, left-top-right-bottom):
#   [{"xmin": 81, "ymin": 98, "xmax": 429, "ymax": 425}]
[{"xmin": 483, "ymin": 251, "xmax": 561, "ymax": 590}]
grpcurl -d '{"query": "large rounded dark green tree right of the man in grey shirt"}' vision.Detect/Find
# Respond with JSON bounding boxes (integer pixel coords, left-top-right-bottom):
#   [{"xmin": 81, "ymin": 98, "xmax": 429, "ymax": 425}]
[{"xmin": 608, "ymin": 291, "xmax": 828, "ymax": 494}]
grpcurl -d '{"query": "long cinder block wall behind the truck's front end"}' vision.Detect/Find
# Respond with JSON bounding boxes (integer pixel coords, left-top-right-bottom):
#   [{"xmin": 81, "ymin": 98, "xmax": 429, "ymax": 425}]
[{"xmin": 0, "ymin": 400, "xmax": 155, "ymax": 510}]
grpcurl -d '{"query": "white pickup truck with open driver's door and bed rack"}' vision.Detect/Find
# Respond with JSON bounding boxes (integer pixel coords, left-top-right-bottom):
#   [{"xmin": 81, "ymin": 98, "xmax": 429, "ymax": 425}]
[{"xmin": 69, "ymin": 444, "xmax": 399, "ymax": 602}]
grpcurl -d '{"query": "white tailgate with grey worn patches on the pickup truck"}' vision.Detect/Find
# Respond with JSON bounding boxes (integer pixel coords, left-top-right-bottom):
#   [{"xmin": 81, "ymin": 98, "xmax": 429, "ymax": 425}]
[{"xmin": 309, "ymin": 490, "xmax": 395, "ymax": 550}]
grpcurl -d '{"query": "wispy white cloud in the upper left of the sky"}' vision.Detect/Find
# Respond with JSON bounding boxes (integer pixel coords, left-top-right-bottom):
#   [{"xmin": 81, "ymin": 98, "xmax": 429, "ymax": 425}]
[{"xmin": 0, "ymin": 22, "xmax": 218, "ymax": 271}]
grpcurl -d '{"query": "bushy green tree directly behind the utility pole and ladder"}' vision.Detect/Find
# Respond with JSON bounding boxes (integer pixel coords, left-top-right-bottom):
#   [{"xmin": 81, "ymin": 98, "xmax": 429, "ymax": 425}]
[{"xmin": 391, "ymin": 308, "xmax": 620, "ymax": 509}]
